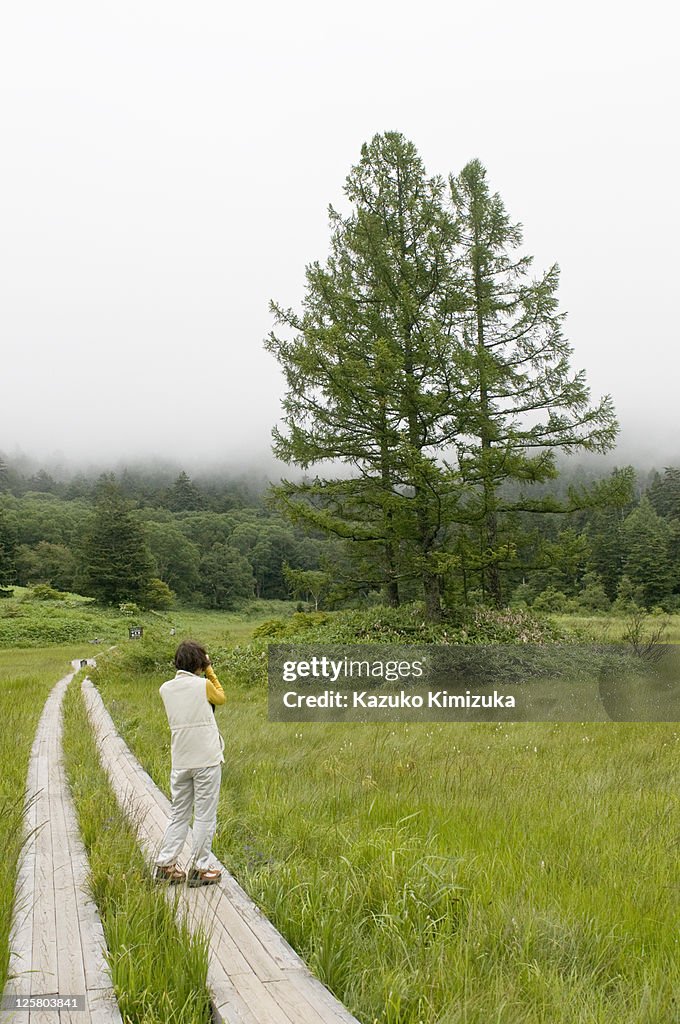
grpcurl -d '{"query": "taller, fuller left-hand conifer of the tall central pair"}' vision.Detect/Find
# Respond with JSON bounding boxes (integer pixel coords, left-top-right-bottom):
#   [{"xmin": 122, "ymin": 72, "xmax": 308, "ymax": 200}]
[{"xmin": 267, "ymin": 132, "xmax": 457, "ymax": 617}]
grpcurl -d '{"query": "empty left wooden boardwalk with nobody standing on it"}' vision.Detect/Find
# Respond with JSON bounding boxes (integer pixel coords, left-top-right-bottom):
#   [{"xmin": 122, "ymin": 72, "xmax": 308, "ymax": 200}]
[{"xmin": 0, "ymin": 665, "xmax": 121, "ymax": 1024}]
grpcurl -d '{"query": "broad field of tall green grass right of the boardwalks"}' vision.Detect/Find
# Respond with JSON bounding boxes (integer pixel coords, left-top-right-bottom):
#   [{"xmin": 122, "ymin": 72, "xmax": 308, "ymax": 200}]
[{"xmin": 97, "ymin": 638, "xmax": 680, "ymax": 1024}]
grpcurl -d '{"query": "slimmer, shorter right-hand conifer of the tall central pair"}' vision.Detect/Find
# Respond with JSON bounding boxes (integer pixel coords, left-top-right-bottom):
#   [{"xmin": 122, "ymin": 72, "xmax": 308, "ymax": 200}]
[{"xmin": 450, "ymin": 160, "xmax": 617, "ymax": 605}]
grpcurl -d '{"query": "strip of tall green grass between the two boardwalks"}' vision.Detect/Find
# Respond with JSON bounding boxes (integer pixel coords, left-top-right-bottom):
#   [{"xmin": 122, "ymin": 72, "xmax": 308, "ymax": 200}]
[{"xmin": 63, "ymin": 684, "xmax": 211, "ymax": 1024}]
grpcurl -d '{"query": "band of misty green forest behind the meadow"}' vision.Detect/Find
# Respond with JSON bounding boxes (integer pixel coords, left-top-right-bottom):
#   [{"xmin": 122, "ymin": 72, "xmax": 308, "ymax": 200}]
[{"xmin": 0, "ymin": 458, "xmax": 680, "ymax": 612}]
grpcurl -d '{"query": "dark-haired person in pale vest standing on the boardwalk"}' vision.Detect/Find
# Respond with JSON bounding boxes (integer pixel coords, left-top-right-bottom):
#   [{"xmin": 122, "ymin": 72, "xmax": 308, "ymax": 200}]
[{"xmin": 155, "ymin": 640, "xmax": 226, "ymax": 887}]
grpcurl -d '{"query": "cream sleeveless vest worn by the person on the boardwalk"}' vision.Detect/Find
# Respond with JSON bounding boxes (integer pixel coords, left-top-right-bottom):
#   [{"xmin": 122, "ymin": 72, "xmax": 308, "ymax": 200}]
[{"xmin": 159, "ymin": 670, "xmax": 224, "ymax": 769}]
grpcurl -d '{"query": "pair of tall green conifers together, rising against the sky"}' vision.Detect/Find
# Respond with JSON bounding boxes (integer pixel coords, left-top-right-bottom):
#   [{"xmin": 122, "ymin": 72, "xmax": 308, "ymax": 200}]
[{"xmin": 266, "ymin": 132, "xmax": 618, "ymax": 621}]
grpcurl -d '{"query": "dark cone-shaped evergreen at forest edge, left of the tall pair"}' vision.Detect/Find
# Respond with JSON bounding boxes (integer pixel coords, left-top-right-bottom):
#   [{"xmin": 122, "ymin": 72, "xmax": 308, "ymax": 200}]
[{"xmin": 82, "ymin": 476, "xmax": 153, "ymax": 605}]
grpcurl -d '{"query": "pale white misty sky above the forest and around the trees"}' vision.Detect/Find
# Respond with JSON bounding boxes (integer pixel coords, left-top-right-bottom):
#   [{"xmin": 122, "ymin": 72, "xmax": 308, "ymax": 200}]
[{"xmin": 0, "ymin": 0, "xmax": 680, "ymax": 468}]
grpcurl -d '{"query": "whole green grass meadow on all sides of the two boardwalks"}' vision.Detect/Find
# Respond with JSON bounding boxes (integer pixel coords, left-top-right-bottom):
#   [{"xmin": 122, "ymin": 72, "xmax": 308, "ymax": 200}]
[{"xmin": 0, "ymin": 606, "xmax": 680, "ymax": 1024}]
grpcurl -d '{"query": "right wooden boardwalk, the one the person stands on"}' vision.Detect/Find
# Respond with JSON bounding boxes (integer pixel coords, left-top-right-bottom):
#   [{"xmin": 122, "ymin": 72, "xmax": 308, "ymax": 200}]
[{"xmin": 83, "ymin": 679, "xmax": 358, "ymax": 1024}]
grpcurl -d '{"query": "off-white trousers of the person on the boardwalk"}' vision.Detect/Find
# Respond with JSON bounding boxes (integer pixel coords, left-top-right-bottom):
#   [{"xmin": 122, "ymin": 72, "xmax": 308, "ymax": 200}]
[{"xmin": 156, "ymin": 764, "xmax": 222, "ymax": 870}]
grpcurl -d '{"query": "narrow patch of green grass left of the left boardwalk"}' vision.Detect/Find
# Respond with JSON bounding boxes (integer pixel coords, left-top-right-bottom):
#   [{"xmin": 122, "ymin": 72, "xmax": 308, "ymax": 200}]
[{"xmin": 0, "ymin": 647, "xmax": 82, "ymax": 990}]
